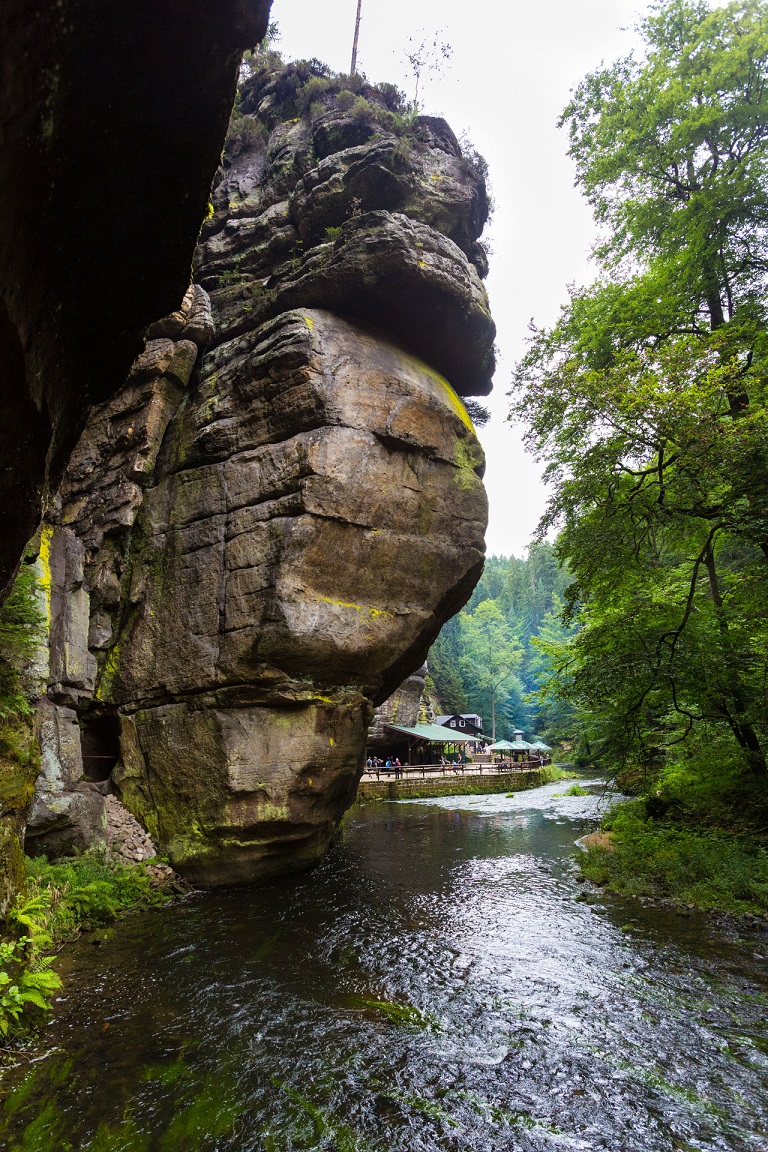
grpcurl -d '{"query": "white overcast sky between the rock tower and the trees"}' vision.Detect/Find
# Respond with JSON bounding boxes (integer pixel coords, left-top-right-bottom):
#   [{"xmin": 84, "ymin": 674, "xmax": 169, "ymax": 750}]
[{"xmin": 272, "ymin": 0, "xmax": 647, "ymax": 556}]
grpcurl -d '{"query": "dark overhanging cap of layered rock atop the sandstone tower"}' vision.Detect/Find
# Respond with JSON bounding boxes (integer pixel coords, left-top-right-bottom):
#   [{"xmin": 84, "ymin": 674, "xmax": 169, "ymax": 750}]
[{"xmin": 196, "ymin": 65, "xmax": 495, "ymax": 396}]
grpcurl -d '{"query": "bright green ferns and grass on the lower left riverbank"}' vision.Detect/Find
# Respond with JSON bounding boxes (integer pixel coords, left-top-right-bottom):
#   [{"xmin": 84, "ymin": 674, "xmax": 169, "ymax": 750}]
[{"xmin": 0, "ymin": 849, "xmax": 169, "ymax": 1041}]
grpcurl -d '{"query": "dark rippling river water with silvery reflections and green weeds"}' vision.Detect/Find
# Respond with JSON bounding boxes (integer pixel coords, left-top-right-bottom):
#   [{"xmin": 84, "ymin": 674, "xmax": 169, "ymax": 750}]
[{"xmin": 0, "ymin": 781, "xmax": 768, "ymax": 1152}]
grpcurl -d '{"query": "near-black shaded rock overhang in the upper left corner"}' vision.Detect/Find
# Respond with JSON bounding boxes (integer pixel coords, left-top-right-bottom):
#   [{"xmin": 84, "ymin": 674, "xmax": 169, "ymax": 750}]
[{"xmin": 0, "ymin": 0, "xmax": 269, "ymax": 591}]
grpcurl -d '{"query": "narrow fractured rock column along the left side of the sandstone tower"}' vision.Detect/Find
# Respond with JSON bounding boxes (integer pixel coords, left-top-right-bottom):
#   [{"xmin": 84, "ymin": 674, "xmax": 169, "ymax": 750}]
[{"xmin": 25, "ymin": 286, "xmax": 213, "ymax": 854}]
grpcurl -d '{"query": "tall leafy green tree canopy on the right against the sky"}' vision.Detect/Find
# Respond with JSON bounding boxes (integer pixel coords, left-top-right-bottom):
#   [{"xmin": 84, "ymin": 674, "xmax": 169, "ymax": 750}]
[{"xmin": 514, "ymin": 0, "xmax": 768, "ymax": 775}]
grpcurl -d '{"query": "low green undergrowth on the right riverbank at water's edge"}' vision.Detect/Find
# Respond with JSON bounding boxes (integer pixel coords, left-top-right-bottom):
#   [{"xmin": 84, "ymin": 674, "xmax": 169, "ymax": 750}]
[{"xmin": 579, "ymin": 801, "xmax": 768, "ymax": 916}]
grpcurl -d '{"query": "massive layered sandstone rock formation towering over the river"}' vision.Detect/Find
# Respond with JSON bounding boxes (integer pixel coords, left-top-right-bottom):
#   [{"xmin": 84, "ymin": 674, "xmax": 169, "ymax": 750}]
[{"xmin": 30, "ymin": 66, "xmax": 494, "ymax": 884}]
